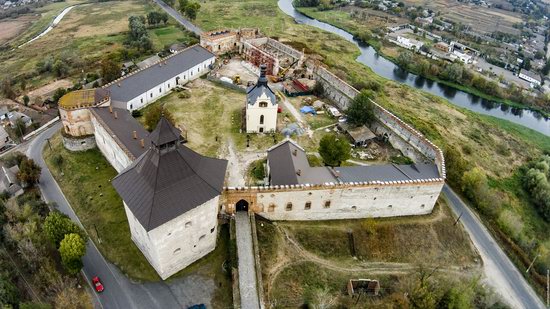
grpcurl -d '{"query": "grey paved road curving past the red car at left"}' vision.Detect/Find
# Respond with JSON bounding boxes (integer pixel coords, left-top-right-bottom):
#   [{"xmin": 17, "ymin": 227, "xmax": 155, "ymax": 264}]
[{"xmin": 27, "ymin": 123, "xmax": 216, "ymax": 309}]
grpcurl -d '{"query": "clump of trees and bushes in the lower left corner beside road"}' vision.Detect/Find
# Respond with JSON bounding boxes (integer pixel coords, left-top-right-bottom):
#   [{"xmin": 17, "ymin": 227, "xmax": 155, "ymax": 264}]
[{"xmin": 0, "ymin": 154, "xmax": 91, "ymax": 309}]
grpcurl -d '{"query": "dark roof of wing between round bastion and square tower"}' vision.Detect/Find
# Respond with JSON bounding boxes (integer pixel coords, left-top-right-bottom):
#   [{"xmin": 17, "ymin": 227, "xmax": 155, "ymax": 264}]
[{"xmin": 90, "ymin": 107, "xmax": 151, "ymax": 159}]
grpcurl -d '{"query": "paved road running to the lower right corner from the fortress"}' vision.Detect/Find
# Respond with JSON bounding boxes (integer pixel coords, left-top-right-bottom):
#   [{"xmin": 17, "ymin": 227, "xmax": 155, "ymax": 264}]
[{"xmin": 443, "ymin": 185, "xmax": 546, "ymax": 309}]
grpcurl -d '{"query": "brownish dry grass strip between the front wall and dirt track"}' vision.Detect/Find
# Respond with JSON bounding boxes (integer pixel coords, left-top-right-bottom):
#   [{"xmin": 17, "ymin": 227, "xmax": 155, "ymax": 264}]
[{"xmin": 281, "ymin": 199, "xmax": 478, "ymax": 266}]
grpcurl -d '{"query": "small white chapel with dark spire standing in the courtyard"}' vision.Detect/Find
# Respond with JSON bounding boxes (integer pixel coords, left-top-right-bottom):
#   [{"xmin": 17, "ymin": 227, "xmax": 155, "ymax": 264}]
[{"xmin": 246, "ymin": 65, "xmax": 279, "ymax": 133}]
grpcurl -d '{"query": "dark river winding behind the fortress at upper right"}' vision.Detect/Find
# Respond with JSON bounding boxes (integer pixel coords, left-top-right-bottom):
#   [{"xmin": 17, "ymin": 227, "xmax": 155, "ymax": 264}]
[{"xmin": 278, "ymin": 0, "xmax": 550, "ymax": 136}]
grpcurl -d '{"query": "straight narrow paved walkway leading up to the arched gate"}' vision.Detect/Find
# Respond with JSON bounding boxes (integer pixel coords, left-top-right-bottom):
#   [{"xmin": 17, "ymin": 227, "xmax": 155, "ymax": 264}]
[{"xmin": 235, "ymin": 211, "xmax": 260, "ymax": 309}]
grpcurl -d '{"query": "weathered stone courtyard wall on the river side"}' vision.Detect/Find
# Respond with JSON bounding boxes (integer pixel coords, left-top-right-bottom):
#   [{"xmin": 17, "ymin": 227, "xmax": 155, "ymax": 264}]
[{"xmin": 307, "ymin": 63, "xmax": 446, "ymax": 178}]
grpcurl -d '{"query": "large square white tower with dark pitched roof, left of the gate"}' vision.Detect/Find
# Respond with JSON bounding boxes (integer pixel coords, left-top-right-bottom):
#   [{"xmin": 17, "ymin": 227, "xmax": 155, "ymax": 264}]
[{"xmin": 113, "ymin": 117, "xmax": 227, "ymax": 279}]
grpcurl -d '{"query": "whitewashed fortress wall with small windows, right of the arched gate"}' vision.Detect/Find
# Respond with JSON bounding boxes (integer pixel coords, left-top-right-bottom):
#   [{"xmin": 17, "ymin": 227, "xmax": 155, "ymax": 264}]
[{"xmin": 253, "ymin": 182, "xmax": 443, "ymax": 221}]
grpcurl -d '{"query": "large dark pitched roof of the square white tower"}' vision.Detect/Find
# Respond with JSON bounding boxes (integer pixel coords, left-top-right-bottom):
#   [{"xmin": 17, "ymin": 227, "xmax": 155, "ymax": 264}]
[{"xmin": 113, "ymin": 119, "xmax": 227, "ymax": 231}]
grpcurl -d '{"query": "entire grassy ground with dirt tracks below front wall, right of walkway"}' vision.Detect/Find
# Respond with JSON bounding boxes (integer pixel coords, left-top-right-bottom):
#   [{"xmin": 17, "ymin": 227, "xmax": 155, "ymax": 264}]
[{"xmin": 257, "ymin": 202, "xmax": 486, "ymax": 308}]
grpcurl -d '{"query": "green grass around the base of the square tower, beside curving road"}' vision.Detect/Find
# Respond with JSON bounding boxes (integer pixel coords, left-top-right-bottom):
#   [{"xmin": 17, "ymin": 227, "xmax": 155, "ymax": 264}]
[{"xmin": 43, "ymin": 134, "xmax": 231, "ymax": 305}]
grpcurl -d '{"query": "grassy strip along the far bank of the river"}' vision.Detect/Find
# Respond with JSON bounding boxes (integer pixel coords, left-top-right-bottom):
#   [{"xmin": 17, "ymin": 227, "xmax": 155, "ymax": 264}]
[{"xmin": 296, "ymin": 7, "xmax": 550, "ymax": 117}]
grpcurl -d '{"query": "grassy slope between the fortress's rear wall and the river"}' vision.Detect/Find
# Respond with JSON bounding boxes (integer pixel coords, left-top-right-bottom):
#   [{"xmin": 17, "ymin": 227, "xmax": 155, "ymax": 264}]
[{"xmin": 197, "ymin": 0, "xmax": 550, "ymax": 291}]
